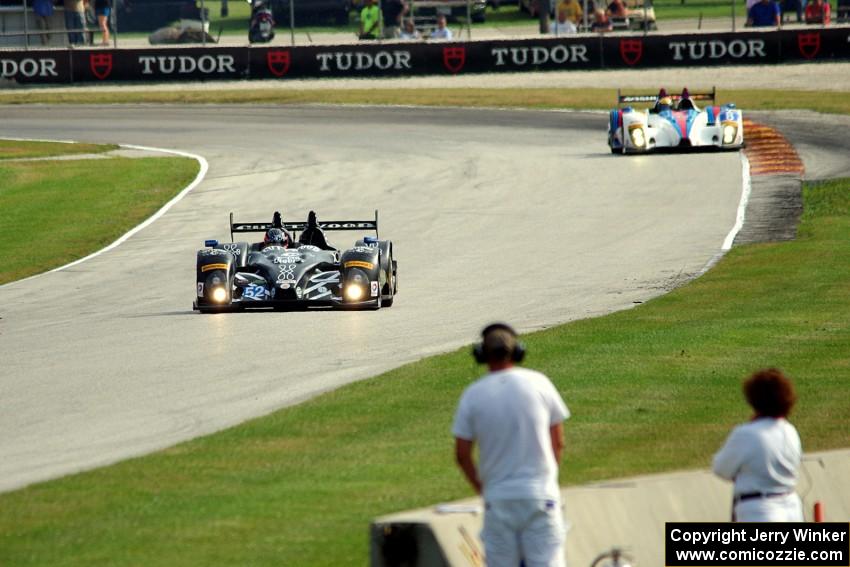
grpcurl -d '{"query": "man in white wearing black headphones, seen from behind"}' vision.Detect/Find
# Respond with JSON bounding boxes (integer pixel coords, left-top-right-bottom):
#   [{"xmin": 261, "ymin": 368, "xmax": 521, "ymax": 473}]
[{"xmin": 452, "ymin": 323, "xmax": 570, "ymax": 567}]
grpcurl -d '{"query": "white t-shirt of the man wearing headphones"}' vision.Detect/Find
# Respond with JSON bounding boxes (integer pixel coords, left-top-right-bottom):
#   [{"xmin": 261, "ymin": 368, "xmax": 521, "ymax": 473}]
[{"xmin": 452, "ymin": 367, "xmax": 570, "ymax": 500}]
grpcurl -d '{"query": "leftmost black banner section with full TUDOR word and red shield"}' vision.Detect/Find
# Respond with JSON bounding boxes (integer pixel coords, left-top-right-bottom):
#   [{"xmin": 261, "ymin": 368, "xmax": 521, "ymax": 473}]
[{"xmin": 72, "ymin": 47, "xmax": 248, "ymax": 82}]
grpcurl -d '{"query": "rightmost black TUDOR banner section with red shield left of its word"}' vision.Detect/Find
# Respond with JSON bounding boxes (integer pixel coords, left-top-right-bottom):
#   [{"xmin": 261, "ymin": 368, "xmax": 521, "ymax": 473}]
[{"xmin": 602, "ymin": 32, "xmax": 779, "ymax": 68}]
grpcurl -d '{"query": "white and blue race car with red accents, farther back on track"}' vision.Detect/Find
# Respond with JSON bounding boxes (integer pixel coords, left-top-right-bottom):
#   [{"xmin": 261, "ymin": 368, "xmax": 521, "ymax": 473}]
[{"xmin": 608, "ymin": 89, "xmax": 744, "ymax": 154}]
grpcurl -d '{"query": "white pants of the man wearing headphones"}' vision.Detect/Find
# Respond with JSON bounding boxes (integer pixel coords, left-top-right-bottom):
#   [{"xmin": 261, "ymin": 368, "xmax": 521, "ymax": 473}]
[{"xmin": 481, "ymin": 500, "xmax": 566, "ymax": 567}]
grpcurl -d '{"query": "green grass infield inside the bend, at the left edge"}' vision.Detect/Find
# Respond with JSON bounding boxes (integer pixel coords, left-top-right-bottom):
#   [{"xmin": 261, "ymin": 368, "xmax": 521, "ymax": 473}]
[{"xmin": 0, "ymin": 155, "xmax": 198, "ymax": 284}]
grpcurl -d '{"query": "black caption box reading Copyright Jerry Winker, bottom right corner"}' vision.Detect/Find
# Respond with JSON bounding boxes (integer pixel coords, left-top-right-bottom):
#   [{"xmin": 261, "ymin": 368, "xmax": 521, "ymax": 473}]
[{"xmin": 664, "ymin": 522, "xmax": 850, "ymax": 567}]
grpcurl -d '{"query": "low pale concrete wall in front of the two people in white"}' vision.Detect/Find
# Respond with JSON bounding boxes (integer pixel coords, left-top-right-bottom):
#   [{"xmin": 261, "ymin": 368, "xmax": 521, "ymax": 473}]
[{"xmin": 371, "ymin": 450, "xmax": 850, "ymax": 567}]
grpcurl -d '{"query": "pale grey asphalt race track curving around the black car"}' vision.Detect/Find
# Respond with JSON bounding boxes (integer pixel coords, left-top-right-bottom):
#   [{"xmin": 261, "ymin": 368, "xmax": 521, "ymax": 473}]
[{"xmin": 0, "ymin": 106, "xmax": 846, "ymax": 490}]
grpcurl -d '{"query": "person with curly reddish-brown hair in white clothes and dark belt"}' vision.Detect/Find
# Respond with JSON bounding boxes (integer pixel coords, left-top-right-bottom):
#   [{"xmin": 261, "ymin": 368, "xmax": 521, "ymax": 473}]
[{"xmin": 713, "ymin": 368, "xmax": 803, "ymax": 522}]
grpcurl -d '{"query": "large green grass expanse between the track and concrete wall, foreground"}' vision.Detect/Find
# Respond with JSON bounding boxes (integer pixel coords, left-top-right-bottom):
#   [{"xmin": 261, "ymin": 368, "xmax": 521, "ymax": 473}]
[{"xmin": 0, "ymin": 176, "xmax": 850, "ymax": 567}]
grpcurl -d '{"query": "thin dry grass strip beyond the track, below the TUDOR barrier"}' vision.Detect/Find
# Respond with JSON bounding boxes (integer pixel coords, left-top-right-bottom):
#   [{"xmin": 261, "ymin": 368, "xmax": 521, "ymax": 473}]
[{"xmin": 0, "ymin": 87, "xmax": 850, "ymax": 114}]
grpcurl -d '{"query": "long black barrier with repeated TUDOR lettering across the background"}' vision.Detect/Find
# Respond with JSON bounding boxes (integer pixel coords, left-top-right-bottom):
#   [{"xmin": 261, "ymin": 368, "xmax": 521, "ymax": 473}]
[{"xmin": 0, "ymin": 27, "xmax": 850, "ymax": 83}]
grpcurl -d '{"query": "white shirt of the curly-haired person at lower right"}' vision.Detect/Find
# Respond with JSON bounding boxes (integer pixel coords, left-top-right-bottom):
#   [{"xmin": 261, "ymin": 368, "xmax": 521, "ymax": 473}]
[{"xmin": 712, "ymin": 417, "xmax": 802, "ymax": 495}]
